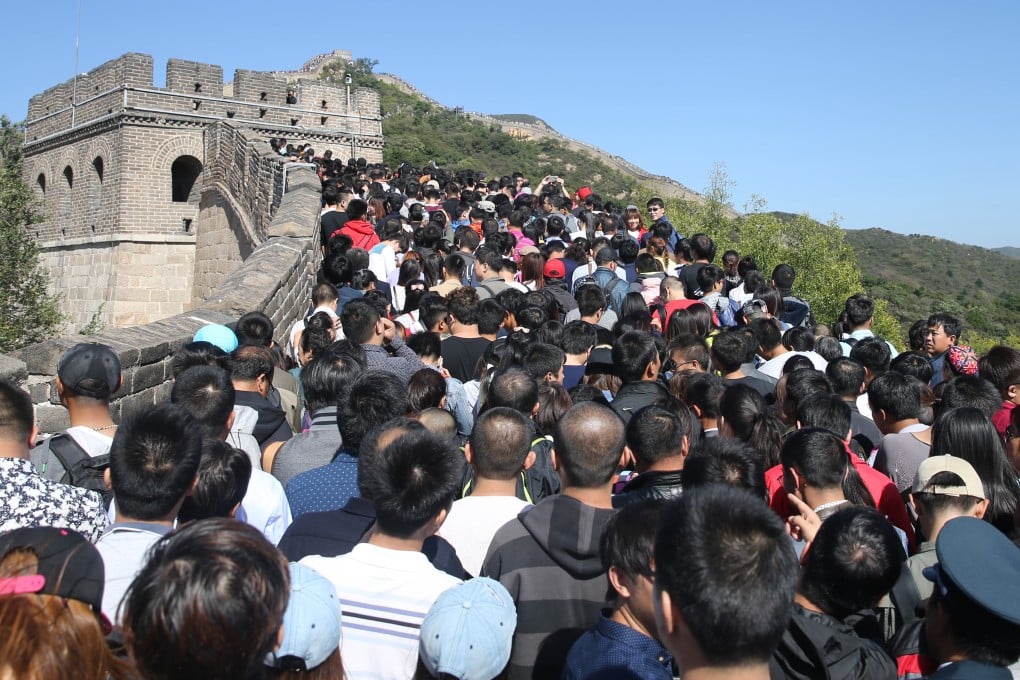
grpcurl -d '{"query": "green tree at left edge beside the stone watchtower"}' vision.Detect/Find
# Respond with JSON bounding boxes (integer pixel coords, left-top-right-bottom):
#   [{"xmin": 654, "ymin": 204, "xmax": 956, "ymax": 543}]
[{"xmin": 0, "ymin": 116, "xmax": 62, "ymax": 352}]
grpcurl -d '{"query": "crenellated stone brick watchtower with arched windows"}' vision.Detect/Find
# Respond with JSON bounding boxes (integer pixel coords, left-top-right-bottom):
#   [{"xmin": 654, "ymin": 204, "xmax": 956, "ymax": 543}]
[{"xmin": 23, "ymin": 53, "xmax": 383, "ymax": 330}]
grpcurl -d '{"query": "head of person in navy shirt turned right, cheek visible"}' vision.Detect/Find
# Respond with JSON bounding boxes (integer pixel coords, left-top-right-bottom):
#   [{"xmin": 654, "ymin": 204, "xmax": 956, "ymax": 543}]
[{"xmin": 599, "ymin": 500, "xmax": 665, "ymax": 634}]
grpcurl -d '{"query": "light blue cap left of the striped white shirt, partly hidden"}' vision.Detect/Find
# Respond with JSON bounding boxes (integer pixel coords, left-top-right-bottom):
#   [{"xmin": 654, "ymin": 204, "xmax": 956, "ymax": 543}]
[{"xmin": 266, "ymin": 562, "xmax": 340, "ymax": 671}]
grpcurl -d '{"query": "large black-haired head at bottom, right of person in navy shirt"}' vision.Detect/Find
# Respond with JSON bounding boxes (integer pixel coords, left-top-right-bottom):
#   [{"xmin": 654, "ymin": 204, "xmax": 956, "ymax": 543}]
[{"xmin": 655, "ymin": 484, "xmax": 798, "ymax": 667}]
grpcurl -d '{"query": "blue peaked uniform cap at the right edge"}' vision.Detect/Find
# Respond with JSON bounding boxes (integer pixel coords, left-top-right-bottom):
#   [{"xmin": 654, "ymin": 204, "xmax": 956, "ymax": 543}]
[{"xmin": 922, "ymin": 517, "xmax": 1020, "ymax": 625}]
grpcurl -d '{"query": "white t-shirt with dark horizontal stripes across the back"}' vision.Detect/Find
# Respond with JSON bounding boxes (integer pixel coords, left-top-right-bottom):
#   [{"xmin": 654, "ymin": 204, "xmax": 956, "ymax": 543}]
[{"xmin": 301, "ymin": 543, "xmax": 461, "ymax": 680}]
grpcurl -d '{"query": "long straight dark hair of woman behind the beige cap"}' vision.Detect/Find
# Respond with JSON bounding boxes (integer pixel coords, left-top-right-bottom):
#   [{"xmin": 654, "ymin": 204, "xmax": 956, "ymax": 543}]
[{"xmin": 931, "ymin": 407, "xmax": 1020, "ymax": 535}]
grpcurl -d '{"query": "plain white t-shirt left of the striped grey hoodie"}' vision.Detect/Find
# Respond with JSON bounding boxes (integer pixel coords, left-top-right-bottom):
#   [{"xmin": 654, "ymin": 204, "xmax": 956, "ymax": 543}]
[{"xmin": 440, "ymin": 495, "xmax": 531, "ymax": 576}]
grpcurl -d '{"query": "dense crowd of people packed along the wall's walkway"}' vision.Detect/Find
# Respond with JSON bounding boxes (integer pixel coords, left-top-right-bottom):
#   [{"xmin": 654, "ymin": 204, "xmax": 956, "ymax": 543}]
[{"xmin": 0, "ymin": 161, "xmax": 1020, "ymax": 680}]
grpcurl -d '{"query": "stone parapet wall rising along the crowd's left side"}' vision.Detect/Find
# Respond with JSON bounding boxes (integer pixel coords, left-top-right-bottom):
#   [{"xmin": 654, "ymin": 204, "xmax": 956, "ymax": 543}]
[{"xmin": 0, "ymin": 167, "xmax": 320, "ymax": 432}]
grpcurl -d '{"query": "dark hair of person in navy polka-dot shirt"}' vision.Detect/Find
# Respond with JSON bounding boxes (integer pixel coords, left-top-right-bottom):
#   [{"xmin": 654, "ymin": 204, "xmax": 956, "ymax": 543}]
[{"xmin": 337, "ymin": 371, "xmax": 407, "ymax": 456}]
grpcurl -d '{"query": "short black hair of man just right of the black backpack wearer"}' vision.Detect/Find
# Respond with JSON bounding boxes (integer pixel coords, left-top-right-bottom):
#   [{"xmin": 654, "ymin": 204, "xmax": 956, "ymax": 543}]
[{"xmin": 110, "ymin": 404, "xmax": 202, "ymax": 522}]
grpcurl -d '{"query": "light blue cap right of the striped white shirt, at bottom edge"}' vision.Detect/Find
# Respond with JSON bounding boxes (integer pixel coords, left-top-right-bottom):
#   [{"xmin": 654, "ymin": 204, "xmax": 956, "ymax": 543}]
[{"xmin": 420, "ymin": 577, "xmax": 517, "ymax": 680}]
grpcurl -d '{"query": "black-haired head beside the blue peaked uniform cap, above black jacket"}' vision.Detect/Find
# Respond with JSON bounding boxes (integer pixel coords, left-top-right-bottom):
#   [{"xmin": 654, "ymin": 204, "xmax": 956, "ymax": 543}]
[{"xmin": 798, "ymin": 506, "xmax": 906, "ymax": 621}]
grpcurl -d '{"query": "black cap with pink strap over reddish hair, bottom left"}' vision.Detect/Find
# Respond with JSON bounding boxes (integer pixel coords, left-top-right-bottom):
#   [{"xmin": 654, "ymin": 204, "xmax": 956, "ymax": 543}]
[{"xmin": 0, "ymin": 526, "xmax": 112, "ymax": 634}]
